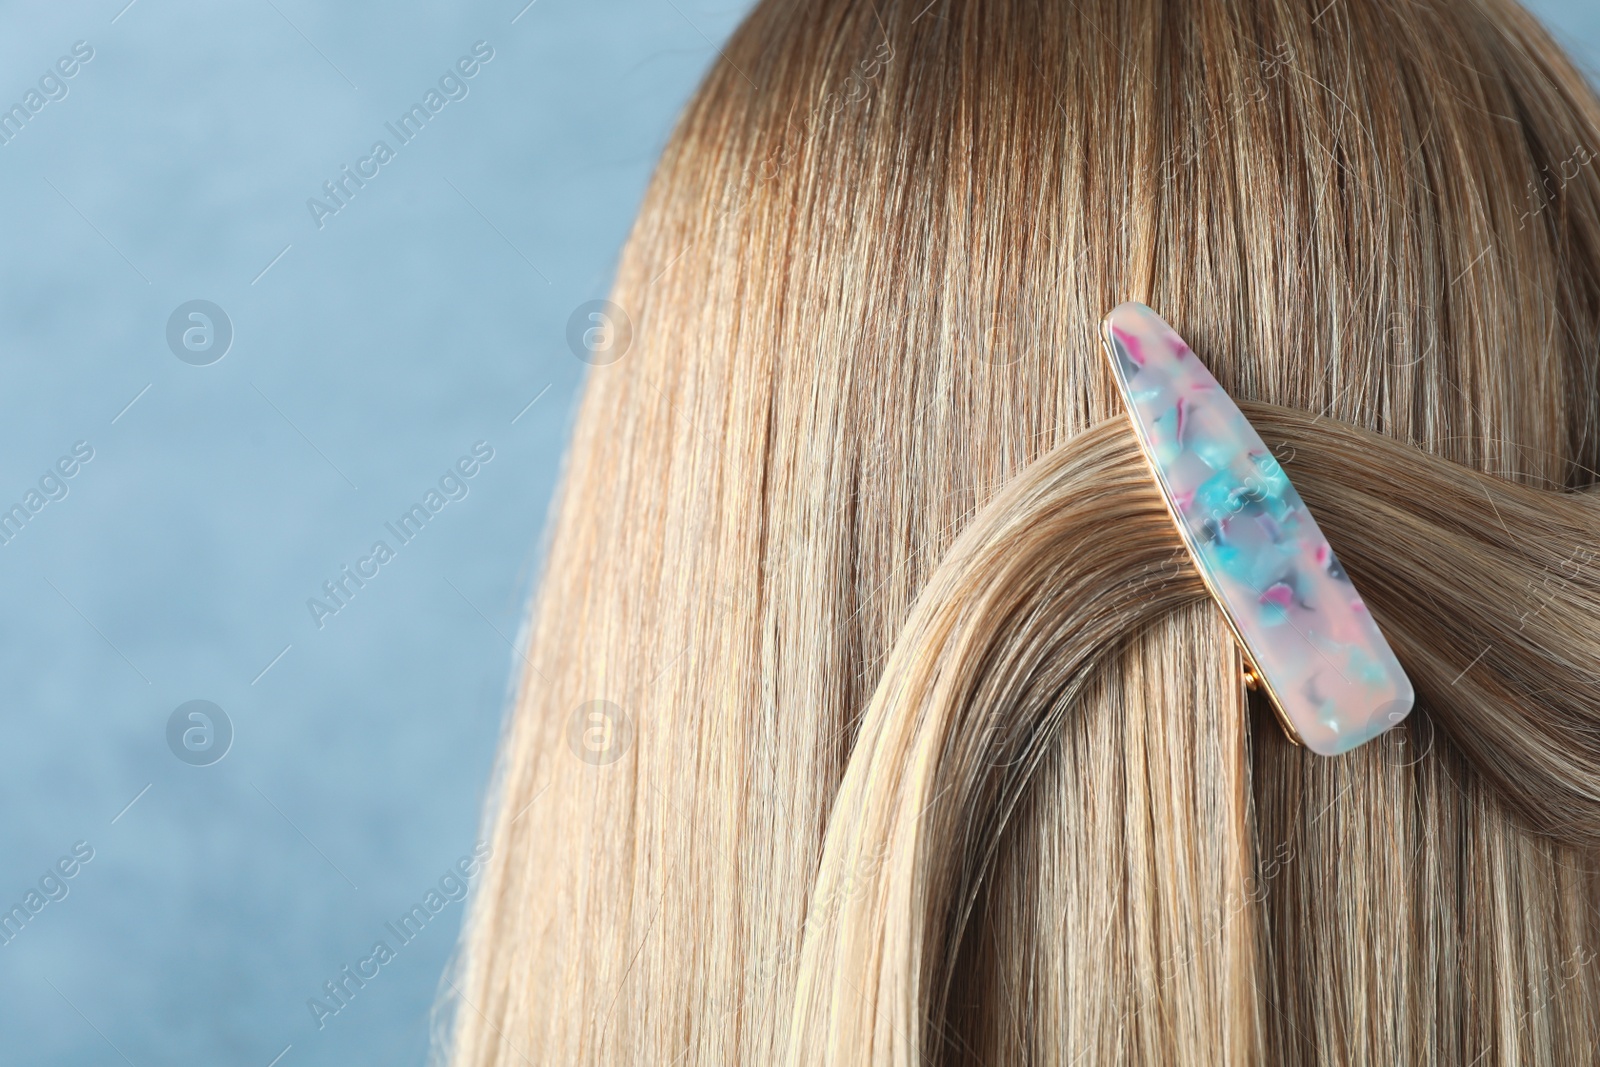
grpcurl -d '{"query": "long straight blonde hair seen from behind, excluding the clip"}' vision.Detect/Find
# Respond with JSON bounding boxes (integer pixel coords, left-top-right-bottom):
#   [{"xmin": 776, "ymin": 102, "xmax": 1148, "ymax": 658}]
[{"xmin": 453, "ymin": 0, "xmax": 1600, "ymax": 1065}]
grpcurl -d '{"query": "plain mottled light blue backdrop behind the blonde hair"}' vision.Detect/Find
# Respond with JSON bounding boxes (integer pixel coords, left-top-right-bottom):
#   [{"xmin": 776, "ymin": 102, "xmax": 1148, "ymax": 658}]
[{"xmin": 0, "ymin": 0, "xmax": 1600, "ymax": 1067}]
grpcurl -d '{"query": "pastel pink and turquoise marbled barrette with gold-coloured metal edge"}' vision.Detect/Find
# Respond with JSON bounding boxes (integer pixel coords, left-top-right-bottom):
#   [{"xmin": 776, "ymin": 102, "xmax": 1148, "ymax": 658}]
[{"xmin": 1101, "ymin": 302, "xmax": 1414, "ymax": 755}]
